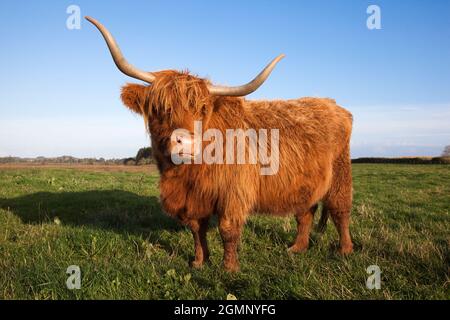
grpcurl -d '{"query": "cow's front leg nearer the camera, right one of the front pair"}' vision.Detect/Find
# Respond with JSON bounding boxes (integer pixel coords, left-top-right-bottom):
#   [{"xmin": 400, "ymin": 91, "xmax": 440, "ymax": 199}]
[{"xmin": 219, "ymin": 216, "xmax": 244, "ymax": 272}]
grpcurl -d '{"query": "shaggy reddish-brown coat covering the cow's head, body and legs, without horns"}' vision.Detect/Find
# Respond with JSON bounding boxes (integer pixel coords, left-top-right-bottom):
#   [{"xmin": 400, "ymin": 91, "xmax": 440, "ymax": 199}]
[{"xmin": 121, "ymin": 71, "xmax": 352, "ymax": 271}]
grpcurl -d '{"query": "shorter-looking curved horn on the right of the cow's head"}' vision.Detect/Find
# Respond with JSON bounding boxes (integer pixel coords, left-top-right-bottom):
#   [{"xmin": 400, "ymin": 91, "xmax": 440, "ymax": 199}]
[{"xmin": 208, "ymin": 54, "xmax": 285, "ymax": 97}]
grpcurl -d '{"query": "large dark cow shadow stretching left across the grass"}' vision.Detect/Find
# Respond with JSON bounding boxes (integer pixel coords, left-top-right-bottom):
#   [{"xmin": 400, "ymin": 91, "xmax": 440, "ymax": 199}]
[{"xmin": 0, "ymin": 190, "xmax": 182, "ymax": 234}]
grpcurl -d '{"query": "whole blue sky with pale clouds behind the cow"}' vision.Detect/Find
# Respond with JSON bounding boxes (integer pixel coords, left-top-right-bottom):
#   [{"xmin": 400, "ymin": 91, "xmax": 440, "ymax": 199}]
[{"xmin": 0, "ymin": 0, "xmax": 450, "ymax": 158}]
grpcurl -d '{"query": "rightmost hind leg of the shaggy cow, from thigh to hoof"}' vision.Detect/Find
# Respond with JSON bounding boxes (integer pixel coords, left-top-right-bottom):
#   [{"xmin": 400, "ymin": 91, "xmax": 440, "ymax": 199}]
[{"xmin": 324, "ymin": 151, "xmax": 353, "ymax": 255}]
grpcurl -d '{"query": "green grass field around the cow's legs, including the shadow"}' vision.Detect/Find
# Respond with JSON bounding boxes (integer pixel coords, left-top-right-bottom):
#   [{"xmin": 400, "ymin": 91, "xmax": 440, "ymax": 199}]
[{"xmin": 0, "ymin": 164, "xmax": 450, "ymax": 299}]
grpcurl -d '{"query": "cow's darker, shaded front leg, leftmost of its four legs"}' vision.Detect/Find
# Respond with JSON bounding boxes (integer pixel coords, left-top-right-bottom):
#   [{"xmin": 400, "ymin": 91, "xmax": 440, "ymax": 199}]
[{"xmin": 188, "ymin": 218, "xmax": 209, "ymax": 268}]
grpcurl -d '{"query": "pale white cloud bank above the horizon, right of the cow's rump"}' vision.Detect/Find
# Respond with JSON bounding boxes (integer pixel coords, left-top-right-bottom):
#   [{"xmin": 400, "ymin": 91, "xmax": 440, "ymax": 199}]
[{"xmin": 350, "ymin": 104, "xmax": 450, "ymax": 156}]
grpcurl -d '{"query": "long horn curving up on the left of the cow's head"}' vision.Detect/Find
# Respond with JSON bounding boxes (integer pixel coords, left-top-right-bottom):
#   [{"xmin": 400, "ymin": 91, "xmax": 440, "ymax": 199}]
[{"xmin": 85, "ymin": 17, "xmax": 155, "ymax": 83}]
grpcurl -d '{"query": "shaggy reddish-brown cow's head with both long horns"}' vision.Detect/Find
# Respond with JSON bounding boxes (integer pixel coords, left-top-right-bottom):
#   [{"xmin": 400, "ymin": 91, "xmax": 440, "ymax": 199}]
[{"xmin": 86, "ymin": 17, "xmax": 284, "ymax": 164}]
